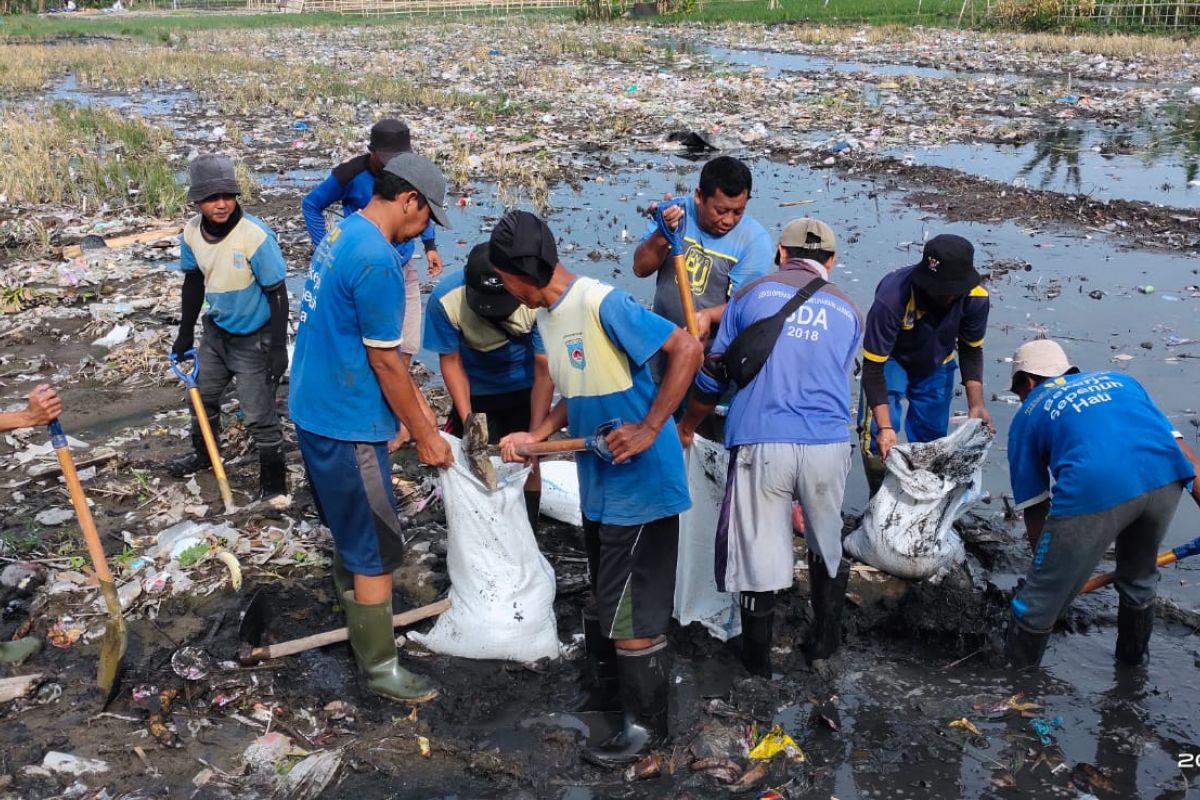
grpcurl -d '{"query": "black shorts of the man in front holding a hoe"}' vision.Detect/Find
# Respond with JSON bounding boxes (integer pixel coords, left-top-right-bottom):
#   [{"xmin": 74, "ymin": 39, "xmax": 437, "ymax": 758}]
[{"xmin": 583, "ymin": 515, "xmax": 679, "ymax": 639}]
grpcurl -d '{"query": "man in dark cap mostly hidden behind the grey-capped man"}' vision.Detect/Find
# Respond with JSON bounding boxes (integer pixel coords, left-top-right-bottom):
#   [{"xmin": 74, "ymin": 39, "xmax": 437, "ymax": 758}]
[{"xmin": 301, "ymin": 120, "xmax": 442, "ymax": 379}]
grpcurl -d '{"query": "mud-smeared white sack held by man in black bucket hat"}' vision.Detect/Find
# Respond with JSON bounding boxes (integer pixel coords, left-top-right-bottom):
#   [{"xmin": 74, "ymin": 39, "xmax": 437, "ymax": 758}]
[{"xmin": 844, "ymin": 420, "xmax": 992, "ymax": 581}]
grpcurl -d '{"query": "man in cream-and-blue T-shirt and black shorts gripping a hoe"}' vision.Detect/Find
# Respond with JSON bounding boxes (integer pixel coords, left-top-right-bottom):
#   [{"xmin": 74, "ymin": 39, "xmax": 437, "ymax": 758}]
[{"xmin": 490, "ymin": 211, "xmax": 703, "ymax": 766}]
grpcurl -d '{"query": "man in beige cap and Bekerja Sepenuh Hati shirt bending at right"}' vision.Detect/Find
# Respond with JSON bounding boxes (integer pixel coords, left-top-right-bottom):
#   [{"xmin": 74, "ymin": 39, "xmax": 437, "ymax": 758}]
[{"xmin": 1004, "ymin": 339, "xmax": 1200, "ymax": 667}]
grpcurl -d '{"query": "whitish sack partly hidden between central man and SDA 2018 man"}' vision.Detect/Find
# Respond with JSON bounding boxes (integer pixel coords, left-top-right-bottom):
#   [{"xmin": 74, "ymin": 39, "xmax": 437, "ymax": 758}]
[{"xmin": 674, "ymin": 437, "xmax": 742, "ymax": 642}]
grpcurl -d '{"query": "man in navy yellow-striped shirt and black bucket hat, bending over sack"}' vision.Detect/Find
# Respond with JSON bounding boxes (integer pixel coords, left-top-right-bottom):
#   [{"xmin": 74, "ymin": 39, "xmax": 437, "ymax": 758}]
[{"xmin": 859, "ymin": 234, "xmax": 991, "ymax": 494}]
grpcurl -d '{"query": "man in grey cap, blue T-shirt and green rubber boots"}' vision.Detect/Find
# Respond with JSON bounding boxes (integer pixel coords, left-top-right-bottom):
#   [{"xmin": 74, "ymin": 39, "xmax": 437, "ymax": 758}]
[{"xmin": 289, "ymin": 152, "xmax": 454, "ymax": 703}]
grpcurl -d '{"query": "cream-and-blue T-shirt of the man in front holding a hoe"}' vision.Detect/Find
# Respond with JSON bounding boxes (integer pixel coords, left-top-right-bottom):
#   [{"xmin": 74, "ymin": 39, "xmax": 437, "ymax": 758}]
[{"xmin": 538, "ymin": 278, "xmax": 691, "ymax": 525}]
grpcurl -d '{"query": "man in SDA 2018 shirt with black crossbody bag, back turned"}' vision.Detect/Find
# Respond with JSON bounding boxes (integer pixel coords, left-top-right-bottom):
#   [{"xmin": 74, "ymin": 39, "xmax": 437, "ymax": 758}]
[{"xmin": 679, "ymin": 218, "xmax": 863, "ymax": 678}]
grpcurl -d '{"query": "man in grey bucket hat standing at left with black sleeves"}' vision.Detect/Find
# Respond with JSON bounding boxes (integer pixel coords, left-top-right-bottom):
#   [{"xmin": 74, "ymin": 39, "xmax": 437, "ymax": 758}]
[{"xmin": 168, "ymin": 154, "xmax": 288, "ymax": 499}]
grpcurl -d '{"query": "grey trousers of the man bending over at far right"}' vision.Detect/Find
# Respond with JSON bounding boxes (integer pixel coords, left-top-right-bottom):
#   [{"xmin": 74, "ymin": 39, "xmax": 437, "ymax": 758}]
[{"xmin": 1013, "ymin": 482, "xmax": 1183, "ymax": 632}]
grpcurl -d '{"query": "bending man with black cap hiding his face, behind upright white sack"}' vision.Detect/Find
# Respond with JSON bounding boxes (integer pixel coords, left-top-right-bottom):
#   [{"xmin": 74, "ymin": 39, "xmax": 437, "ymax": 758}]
[{"xmin": 425, "ymin": 242, "xmax": 554, "ymax": 530}]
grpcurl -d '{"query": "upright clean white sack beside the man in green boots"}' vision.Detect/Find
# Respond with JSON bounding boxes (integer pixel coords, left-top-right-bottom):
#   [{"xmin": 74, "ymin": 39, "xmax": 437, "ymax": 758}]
[{"xmin": 409, "ymin": 434, "xmax": 559, "ymax": 663}]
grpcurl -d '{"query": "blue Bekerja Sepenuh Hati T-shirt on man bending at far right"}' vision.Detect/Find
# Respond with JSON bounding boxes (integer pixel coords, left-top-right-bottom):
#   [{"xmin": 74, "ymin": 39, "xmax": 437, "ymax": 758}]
[{"xmin": 1008, "ymin": 372, "xmax": 1195, "ymax": 517}]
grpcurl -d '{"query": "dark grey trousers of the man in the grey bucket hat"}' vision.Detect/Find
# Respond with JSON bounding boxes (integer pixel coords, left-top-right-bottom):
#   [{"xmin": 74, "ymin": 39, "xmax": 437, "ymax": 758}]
[{"xmin": 192, "ymin": 317, "xmax": 283, "ymax": 452}]
